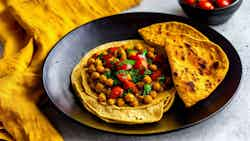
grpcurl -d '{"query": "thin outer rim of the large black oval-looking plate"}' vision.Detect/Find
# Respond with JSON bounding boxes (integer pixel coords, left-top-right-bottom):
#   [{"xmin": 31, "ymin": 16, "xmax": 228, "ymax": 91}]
[{"xmin": 42, "ymin": 12, "xmax": 242, "ymax": 136}]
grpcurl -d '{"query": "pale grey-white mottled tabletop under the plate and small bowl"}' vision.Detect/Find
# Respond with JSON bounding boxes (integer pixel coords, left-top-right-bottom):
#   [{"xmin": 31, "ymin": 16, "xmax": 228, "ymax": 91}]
[{"xmin": 0, "ymin": 0, "xmax": 250, "ymax": 141}]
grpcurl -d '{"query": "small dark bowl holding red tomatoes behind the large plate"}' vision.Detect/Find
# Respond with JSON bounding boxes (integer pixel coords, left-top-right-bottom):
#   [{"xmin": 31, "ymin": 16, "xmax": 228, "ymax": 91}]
[{"xmin": 178, "ymin": 0, "xmax": 243, "ymax": 25}]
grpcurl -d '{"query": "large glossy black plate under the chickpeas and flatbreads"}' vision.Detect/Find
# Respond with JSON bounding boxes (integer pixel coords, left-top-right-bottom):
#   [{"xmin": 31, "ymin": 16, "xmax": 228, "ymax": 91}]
[{"xmin": 43, "ymin": 13, "xmax": 242, "ymax": 134}]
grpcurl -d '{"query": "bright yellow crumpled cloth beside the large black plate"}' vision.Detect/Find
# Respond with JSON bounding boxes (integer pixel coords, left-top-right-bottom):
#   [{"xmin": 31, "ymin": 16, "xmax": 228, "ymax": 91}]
[{"xmin": 0, "ymin": 0, "xmax": 140, "ymax": 141}]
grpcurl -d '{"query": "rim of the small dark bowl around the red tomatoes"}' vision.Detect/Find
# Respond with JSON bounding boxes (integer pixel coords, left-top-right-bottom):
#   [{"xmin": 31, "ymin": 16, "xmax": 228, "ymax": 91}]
[{"xmin": 178, "ymin": 0, "xmax": 243, "ymax": 12}]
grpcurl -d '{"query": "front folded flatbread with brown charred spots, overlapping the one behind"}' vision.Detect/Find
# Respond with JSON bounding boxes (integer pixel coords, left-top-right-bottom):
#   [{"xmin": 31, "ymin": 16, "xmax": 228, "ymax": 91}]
[{"xmin": 140, "ymin": 32, "xmax": 229, "ymax": 107}]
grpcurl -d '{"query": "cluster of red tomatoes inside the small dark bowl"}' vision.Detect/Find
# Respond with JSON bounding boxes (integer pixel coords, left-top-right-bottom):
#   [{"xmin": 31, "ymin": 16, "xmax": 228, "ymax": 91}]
[{"xmin": 183, "ymin": 0, "xmax": 233, "ymax": 10}]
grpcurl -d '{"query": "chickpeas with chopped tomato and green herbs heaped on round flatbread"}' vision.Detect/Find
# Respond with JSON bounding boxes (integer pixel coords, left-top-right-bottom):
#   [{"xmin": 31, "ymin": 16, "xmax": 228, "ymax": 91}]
[{"xmin": 84, "ymin": 44, "xmax": 172, "ymax": 107}]
